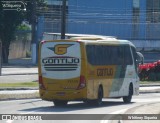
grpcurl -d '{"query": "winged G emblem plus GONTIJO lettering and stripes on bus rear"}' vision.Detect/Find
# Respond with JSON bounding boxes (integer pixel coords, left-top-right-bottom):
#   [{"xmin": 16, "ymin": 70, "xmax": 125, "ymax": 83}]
[{"xmin": 42, "ymin": 44, "xmax": 80, "ymax": 71}]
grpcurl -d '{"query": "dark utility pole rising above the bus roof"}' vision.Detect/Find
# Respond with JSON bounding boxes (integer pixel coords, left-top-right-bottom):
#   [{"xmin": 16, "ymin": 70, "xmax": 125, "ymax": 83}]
[{"xmin": 61, "ymin": 0, "xmax": 66, "ymax": 39}]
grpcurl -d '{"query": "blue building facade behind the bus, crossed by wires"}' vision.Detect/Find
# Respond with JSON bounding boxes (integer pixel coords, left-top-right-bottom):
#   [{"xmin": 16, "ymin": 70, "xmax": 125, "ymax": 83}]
[{"xmin": 37, "ymin": 0, "xmax": 160, "ymax": 49}]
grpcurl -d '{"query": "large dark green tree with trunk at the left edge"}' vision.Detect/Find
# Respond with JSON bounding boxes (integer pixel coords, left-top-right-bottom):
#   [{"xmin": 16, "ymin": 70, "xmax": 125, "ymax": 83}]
[{"xmin": 0, "ymin": 0, "xmax": 45, "ymax": 63}]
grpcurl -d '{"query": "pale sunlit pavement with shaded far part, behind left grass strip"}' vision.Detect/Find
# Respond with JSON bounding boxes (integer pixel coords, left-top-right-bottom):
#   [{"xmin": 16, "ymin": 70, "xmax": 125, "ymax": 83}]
[{"xmin": 0, "ymin": 58, "xmax": 38, "ymax": 83}]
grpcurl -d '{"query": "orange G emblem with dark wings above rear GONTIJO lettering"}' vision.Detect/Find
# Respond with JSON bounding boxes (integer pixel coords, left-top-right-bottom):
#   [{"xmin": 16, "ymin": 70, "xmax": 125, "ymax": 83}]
[{"xmin": 48, "ymin": 44, "xmax": 73, "ymax": 55}]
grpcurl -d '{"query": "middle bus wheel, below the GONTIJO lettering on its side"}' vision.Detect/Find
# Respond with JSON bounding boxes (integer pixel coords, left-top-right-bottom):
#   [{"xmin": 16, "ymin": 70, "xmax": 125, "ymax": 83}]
[{"xmin": 94, "ymin": 86, "xmax": 103, "ymax": 106}]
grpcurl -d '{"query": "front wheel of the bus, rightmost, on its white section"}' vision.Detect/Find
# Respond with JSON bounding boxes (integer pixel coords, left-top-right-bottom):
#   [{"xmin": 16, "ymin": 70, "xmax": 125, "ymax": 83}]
[{"xmin": 123, "ymin": 84, "xmax": 133, "ymax": 103}]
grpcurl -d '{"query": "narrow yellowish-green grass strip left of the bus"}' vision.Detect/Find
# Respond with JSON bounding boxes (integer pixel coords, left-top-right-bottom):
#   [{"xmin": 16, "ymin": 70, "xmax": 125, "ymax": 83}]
[{"xmin": 0, "ymin": 82, "xmax": 38, "ymax": 88}]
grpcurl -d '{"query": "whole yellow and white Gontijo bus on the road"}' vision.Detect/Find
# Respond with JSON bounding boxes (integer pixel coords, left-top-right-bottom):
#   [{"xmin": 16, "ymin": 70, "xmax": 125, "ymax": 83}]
[{"xmin": 38, "ymin": 36, "xmax": 139, "ymax": 106}]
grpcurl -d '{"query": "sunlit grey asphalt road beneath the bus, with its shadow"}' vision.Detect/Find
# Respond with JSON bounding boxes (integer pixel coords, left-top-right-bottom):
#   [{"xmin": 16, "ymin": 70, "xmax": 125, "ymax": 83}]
[{"xmin": 0, "ymin": 93, "xmax": 160, "ymax": 123}]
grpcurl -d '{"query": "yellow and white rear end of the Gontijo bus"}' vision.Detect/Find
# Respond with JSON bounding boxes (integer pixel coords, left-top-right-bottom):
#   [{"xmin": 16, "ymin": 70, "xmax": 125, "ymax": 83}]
[{"xmin": 39, "ymin": 41, "xmax": 86, "ymax": 105}]
